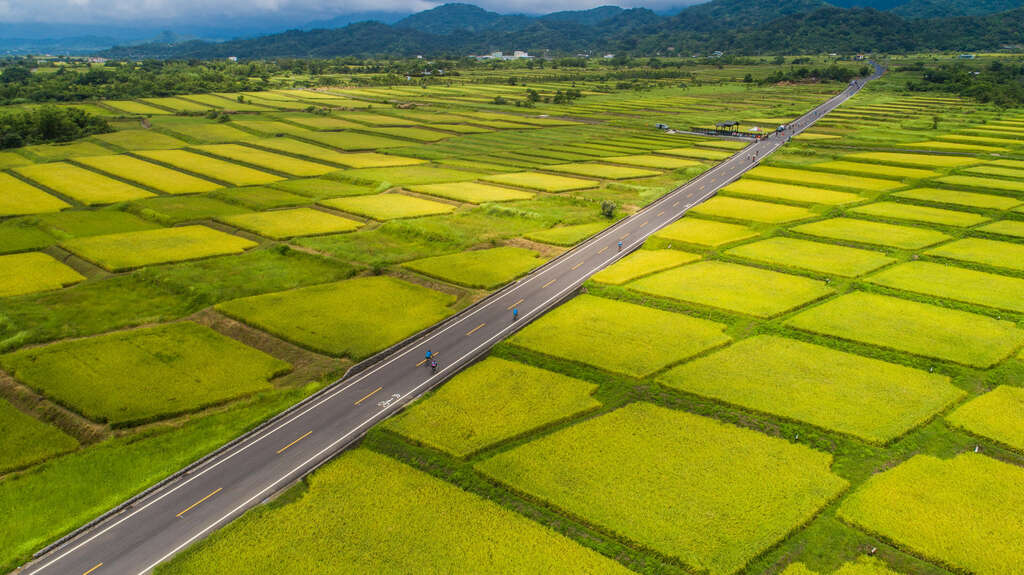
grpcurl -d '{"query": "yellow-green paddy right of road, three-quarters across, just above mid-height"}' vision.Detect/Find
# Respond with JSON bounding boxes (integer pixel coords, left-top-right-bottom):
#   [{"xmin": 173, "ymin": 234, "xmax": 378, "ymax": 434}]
[{"xmin": 726, "ymin": 237, "xmax": 896, "ymax": 277}]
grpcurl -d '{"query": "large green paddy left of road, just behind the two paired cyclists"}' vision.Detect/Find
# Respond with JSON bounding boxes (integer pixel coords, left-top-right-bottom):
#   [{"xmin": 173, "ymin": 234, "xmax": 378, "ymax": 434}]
[{"xmin": 217, "ymin": 275, "xmax": 455, "ymax": 359}]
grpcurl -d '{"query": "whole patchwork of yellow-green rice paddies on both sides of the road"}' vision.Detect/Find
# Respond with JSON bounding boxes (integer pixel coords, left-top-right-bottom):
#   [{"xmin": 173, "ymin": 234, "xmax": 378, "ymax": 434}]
[{"xmin": 0, "ymin": 56, "xmax": 1024, "ymax": 575}]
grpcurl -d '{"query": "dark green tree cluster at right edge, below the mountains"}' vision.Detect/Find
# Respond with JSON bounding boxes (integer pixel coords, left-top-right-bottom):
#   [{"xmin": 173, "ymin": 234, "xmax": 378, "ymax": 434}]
[{"xmin": 906, "ymin": 60, "xmax": 1024, "ymax": 107}]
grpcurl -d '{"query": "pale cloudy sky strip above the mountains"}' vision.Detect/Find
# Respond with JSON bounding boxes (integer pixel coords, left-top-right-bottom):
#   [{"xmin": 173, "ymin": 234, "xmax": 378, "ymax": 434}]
[{"xmin": 0, "ymin": 0, "xmax": 698, "ymax": 26}]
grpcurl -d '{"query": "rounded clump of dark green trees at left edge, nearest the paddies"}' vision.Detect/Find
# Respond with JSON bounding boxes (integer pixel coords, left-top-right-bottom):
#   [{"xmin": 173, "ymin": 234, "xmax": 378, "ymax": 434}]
[{"xmin": 0, "ymin": 105, "xmax": 113, "ymax": 148}]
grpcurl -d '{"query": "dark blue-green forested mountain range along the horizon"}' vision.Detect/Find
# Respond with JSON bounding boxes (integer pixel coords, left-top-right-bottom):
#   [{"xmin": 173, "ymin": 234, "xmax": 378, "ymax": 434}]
[{"xmin": 94, "ymin": 0, "xmax": 1024, "ymax": 58}]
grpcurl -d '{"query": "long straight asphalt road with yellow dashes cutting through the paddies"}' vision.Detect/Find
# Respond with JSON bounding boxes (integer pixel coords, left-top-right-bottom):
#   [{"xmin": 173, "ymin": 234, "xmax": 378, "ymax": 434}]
[{"xmin": 25, "ymin": 63, "xmax": 879, "ymax": 575}]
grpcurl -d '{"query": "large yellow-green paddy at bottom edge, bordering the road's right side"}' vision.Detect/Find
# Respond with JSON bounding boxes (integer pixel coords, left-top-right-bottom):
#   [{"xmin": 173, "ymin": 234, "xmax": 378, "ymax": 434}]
[{"xmin": 157, "ymin": 449, "xmax": 631, "ymax": 575}]
